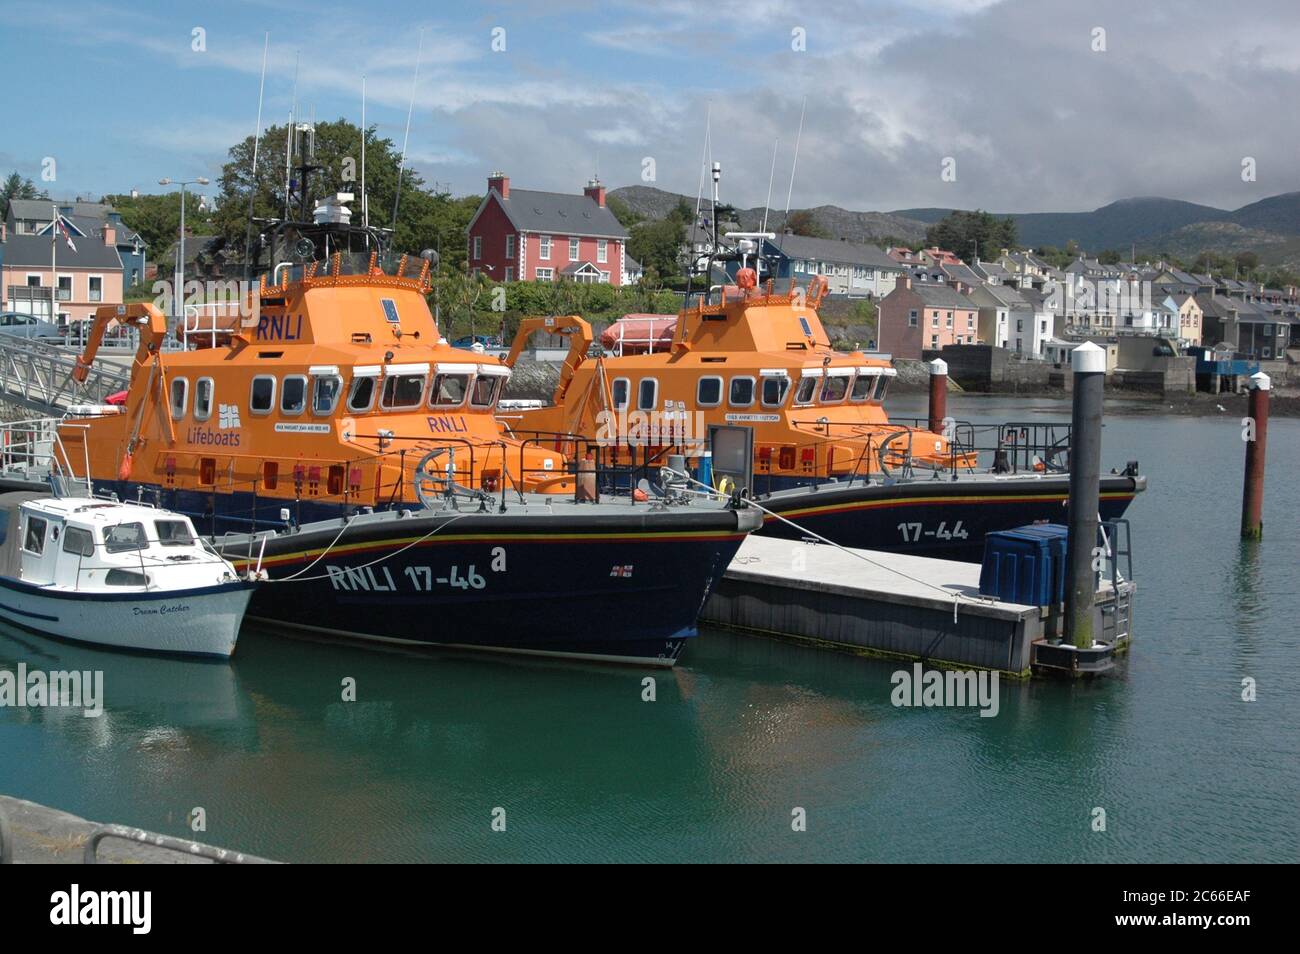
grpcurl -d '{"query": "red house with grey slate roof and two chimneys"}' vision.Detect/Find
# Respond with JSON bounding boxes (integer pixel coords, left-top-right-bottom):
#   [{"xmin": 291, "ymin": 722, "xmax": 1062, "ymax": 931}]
[{"xmin": 468, "ymin": 173, "xmax": 631, "ymax": 285}]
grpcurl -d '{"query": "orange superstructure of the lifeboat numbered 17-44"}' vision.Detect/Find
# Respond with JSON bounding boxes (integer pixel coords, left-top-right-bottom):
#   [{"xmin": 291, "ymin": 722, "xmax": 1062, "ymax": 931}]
[{"xmin": 501, "ymin": 269, "xmax": 972, "ymax": 486}]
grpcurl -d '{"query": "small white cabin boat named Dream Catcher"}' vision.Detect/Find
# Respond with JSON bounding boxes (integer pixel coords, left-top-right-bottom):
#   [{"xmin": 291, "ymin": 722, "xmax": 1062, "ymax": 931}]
[{"xmin": 0, "ymin": 493, "xmax": 252, "ymax": 659}]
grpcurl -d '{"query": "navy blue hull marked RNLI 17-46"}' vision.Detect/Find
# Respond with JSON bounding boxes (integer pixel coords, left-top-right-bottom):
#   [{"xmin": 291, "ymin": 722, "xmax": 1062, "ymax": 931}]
[{"xmin": 48, "ymin": 481, "xmax": 758, "ymax": 665}]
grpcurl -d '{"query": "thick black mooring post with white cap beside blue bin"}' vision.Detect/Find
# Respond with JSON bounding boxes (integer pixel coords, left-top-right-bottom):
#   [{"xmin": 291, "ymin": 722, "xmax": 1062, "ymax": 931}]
[{"xmin": 1065, "ymin": 342, "xmax": 1106, "ymax": 649}]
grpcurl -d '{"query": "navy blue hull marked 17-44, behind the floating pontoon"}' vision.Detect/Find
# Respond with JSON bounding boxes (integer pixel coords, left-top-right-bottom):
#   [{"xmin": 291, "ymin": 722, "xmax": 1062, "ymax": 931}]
[{"xmin": 758, "ymin": 476, "xmax": 1140, "ymax": 561}]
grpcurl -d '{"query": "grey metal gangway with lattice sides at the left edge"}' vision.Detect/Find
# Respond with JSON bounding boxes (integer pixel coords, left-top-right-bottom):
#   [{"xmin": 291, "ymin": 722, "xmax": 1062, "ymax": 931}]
[{"xmin": 0, "ymin": 334, "xmax": 133, "ymax": 415}]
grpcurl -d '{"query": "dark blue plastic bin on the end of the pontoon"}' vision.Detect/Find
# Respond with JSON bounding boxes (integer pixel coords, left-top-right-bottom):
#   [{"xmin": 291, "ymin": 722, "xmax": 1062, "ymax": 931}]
[{"xmin": 979, "ymin": 524, "xmax": 1069, "ymax": 606}]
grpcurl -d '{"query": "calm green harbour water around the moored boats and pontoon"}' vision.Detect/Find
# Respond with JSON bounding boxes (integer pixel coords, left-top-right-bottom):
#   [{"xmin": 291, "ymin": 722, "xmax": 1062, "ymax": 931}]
[{"xmin": 0, "ymin": 398, "xmax": 1300, "ymax": 862}]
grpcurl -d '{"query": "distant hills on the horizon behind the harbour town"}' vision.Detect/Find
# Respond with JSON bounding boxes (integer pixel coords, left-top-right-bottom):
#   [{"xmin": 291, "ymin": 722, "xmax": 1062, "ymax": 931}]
[{"xmin": 611, "ymin": 186, "xmax": 1300, "ymax": 268}]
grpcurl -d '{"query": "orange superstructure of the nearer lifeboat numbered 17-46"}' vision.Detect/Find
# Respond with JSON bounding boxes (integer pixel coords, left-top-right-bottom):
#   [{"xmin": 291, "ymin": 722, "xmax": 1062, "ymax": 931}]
[{"xmin": 62, "ymin": 255, "xmax": 573, "ymax": 530}]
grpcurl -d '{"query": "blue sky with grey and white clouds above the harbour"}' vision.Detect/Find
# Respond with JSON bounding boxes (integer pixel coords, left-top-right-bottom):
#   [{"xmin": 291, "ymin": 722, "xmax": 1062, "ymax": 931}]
[{"xmin": 0, "ymin": 0, "xmax": 1300, "ymax": 212}]
